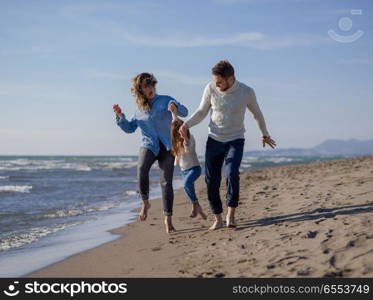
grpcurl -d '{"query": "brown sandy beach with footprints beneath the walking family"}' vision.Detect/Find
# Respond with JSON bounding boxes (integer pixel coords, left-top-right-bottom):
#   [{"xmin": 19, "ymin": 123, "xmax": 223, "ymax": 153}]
[{"xmin": 27, "ymin": 157, "xmax": 373, "ymax": 278}]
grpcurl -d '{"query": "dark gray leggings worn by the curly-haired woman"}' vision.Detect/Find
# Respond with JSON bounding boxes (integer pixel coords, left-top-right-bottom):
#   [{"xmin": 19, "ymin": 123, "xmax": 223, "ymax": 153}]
[{"xmin": 137, "ymin": 143, "xmax": 175, "ymax": 216}]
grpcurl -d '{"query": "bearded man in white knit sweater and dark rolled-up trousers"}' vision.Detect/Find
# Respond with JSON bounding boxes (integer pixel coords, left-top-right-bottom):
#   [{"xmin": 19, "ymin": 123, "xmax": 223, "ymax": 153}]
[{"xmin": 180, "ymin": 61, "xmax": 276, "ymax": 230}]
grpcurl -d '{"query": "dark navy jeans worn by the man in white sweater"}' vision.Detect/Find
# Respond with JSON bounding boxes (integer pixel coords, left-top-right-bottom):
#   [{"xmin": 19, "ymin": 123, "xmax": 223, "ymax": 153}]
[{"xmin": 205, "ymin": 137, "xmax": 245, "ymax": 214}]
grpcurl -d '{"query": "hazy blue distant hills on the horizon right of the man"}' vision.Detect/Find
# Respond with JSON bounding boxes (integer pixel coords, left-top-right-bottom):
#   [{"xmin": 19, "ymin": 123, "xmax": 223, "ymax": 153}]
[{"xmin": 245, "ymin": 139, "xmax": 373, "ymax": 156}]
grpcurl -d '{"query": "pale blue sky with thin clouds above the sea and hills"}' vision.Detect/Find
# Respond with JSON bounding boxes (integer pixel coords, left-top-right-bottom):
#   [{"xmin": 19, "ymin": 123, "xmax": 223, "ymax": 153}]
[{"xmin": 0, "ymin": 0, "xmax": 373, "ymax": 155}]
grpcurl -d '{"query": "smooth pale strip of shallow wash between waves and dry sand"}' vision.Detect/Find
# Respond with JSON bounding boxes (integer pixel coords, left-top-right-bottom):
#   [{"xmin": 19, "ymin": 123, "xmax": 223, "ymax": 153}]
[{"xmin": 0, "ymin": 179, "xmax": 181, "ymax": 277}]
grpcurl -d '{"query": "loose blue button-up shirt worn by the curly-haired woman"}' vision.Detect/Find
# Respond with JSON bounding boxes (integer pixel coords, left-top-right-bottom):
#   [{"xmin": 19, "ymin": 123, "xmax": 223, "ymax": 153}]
[{"xmin": 117, "ymin": 95, "xmax": 188, "ymax": 156}]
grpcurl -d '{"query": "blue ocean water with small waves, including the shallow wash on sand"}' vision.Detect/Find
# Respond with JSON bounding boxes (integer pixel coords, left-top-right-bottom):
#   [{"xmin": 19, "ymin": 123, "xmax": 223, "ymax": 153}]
[{"xmin": 0, "ymin": 156, "xmax": 337, "ymax": 277}]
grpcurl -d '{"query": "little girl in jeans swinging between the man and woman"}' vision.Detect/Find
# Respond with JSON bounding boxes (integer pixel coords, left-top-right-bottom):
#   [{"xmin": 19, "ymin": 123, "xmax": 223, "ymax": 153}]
[{"xmin": 171, "ymin": 113, "xmax": 207, "ymax": 219}]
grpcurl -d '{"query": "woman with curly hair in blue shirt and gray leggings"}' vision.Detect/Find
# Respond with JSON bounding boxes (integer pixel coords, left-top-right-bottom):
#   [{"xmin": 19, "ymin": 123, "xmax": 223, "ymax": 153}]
[{"xmin": 113, "ymin": 73, "xmax": 188, "ymax": 233}]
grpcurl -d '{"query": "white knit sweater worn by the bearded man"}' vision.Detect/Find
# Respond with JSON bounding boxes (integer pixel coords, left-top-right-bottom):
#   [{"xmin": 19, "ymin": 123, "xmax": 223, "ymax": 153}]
[{"xmin": 186, "ymin": 80, "xmax": 269, "ymax": 142}]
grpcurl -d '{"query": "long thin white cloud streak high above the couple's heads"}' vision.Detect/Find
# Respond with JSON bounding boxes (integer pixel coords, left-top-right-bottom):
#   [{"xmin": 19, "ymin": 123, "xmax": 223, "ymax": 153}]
[{"xmin": 123, "ymin": 32, "xmax": 330, "ymax": 50}]
